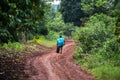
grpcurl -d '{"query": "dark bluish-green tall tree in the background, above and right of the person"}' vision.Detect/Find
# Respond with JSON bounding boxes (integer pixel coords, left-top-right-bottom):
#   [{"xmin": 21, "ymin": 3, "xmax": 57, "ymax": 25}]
[{"xmin": 60, "ymin": 0, "xmax": 84, "ymax": 26}]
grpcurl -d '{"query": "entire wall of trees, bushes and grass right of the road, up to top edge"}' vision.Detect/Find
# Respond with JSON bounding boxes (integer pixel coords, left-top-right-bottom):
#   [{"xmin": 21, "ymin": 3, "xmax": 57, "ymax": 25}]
[{"xmin": 74, "ymin": 0, "xmax": 120, "ymax": 80}]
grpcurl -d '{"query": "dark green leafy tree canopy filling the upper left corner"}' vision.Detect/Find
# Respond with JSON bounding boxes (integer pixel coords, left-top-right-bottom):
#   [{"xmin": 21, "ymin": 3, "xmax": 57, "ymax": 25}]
[{"xmin": 0, "ymin": 0, "xmax": 45, "ymax": 43}]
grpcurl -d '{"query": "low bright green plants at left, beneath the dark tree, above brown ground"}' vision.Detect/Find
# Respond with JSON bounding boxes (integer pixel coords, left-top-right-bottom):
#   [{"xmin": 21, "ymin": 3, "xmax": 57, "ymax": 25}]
[{"xmin": 2, "ymin": 42, "xmax": 25, "ymax": 51}]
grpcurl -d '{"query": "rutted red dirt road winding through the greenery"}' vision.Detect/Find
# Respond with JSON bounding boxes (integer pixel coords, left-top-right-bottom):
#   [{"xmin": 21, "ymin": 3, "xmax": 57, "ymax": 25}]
[{"xmin": 25, "ymin": 40, "xmax": 95, "ymax": 80}]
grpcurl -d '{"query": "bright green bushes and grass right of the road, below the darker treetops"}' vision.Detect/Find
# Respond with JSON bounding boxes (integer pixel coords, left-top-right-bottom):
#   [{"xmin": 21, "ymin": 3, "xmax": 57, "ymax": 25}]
[{"xmin": 74, "ymin": 14, "xmax": 120, "ymax": 80}]
